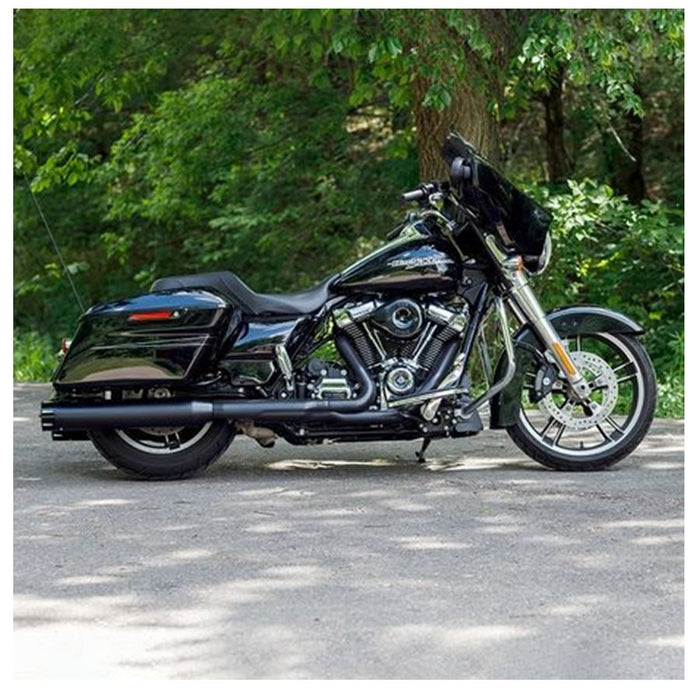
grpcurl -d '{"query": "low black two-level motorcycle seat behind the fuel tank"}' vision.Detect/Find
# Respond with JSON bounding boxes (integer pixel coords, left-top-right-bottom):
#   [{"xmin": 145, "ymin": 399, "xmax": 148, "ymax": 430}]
[{"xmin": 151, "ymin": 271, "xmax": 338, "ymax": 316}]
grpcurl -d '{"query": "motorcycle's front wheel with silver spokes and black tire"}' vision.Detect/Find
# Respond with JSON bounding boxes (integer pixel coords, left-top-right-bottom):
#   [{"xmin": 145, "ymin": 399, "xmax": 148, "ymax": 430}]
[{"xmin": 508, "ymin": 333, "xmax": 656, "ymax": 471}]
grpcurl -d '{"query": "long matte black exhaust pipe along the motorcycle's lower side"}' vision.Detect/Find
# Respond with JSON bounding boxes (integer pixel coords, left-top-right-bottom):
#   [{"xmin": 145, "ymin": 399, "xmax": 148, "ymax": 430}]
[{"xmin": 41, "ymin": 336, "xmax": 401, "ymax": 432}]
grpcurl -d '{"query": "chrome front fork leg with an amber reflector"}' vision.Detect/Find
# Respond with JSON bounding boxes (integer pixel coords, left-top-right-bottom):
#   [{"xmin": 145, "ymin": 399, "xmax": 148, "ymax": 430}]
[{"xmin": 486, "ymin": 236, "xmax": 591, "ymax": 401}]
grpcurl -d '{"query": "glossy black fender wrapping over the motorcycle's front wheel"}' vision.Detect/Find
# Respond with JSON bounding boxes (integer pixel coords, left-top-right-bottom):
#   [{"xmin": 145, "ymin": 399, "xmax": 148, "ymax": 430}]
[{"xmin": 490, "ymin": 306, "xmax": 644, "ymax": 429}]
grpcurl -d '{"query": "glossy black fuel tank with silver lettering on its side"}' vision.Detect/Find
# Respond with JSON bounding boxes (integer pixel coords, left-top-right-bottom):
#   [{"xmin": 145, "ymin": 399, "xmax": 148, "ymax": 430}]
[{"xmin": 332, "ymin": 222, "xmax": 462, "ymax": 294}]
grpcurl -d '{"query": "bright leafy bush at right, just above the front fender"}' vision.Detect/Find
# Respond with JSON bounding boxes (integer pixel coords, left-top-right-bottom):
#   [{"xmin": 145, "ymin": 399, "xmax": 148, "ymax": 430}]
[{"xmin": 530, "ymin": 181, "xmax": 684, "ymax": 411}]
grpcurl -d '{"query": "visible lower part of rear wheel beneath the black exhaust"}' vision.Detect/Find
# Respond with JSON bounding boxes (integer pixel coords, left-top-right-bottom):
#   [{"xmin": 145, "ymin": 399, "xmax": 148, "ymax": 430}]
[{"xmin": 90, "ymin": 421, "xmax": 235, "ymax": 480}]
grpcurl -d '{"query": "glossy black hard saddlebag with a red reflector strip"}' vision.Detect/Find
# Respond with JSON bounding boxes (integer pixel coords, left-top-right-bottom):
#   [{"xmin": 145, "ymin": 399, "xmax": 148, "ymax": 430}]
[{"xmin": 52, "ymin": 290, "xmax": 241, "ymax": 390}]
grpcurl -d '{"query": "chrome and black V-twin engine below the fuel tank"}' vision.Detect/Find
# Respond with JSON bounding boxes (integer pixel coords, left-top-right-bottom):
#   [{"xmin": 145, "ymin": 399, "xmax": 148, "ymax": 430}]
[{"xmin": 322, "ymin": 299, "xmax": 468, "ymax": 399}]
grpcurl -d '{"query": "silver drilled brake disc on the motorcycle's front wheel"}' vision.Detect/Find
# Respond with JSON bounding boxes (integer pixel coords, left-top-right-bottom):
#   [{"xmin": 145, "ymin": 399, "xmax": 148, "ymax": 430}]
[{"xmin": 538, "ymin": 350, "xmax": 618, "ymax": 431}]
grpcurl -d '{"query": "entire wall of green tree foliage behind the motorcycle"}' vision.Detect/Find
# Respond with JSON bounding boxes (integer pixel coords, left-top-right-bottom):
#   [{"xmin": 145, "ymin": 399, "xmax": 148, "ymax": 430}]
[{"xmin": 13, "ymin": 8, "xmax": 684, "ymax": 412}]
